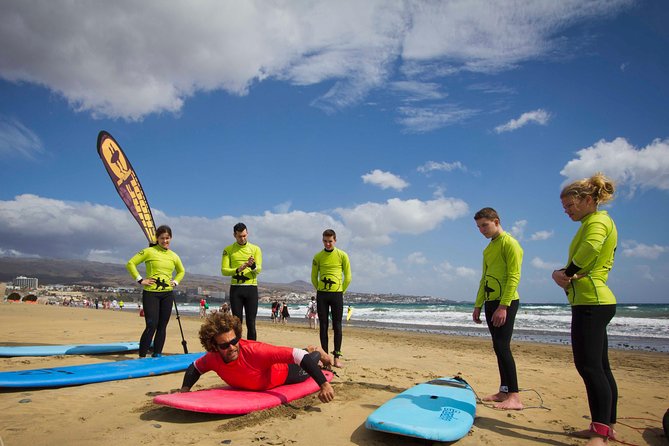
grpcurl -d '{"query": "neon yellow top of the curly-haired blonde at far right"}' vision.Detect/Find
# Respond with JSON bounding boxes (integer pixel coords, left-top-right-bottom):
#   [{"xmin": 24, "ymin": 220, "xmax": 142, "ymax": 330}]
[{"xmin": 567, "ymin": 211, "xmax": 618, "ymax": 305}]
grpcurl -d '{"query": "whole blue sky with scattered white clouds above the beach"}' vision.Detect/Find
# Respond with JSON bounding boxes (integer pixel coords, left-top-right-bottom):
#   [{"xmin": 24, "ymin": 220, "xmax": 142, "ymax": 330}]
[{"xmin": 0, "ymin": 0, "xmax": 669, "ymax": 303}]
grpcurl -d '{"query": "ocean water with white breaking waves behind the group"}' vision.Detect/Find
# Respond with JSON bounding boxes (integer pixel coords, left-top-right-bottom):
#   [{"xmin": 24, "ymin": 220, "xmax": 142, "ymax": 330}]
[{"xmin": 174, "ymin": 302, "xmax": 669, "ymax": 352}]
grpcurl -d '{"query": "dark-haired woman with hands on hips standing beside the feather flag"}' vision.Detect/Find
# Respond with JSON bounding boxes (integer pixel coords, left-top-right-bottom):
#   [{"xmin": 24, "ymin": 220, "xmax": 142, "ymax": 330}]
[{"xmin": 126, "ymin": 225, "xmax": 186, "ymax": 357}]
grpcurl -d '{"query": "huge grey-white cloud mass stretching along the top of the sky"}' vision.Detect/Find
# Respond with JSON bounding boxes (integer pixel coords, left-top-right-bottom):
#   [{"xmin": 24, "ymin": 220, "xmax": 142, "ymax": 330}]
[{"xmin": 0, "ymin": 0, "xmax": 631, "ymax": 120}]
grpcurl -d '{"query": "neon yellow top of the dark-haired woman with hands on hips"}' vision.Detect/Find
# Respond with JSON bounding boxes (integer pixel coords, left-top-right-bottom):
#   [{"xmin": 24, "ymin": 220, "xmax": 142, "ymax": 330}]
[{"xmin": 125, "ymin": 245, "xmax": 186, "ymax": 292}]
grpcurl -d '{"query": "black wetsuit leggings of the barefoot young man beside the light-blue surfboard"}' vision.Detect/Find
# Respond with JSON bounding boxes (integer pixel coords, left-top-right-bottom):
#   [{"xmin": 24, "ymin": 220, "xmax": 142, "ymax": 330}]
[{"xmin": 485, "ymin": 299, "xmax": 520, "ymax": 393}]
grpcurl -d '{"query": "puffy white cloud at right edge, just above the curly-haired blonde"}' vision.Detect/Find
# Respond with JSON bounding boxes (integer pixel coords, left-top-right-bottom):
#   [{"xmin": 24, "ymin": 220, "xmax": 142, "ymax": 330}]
[{"xmin": 560, "ymin": 138, "xmax": 669, "ymax": 193}]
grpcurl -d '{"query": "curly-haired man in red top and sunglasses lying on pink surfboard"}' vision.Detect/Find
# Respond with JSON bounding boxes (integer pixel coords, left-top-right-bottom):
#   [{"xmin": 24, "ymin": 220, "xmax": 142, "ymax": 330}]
[{"xmin": 180, "ymin": 312, "xmax": 334, "ymax": 403}]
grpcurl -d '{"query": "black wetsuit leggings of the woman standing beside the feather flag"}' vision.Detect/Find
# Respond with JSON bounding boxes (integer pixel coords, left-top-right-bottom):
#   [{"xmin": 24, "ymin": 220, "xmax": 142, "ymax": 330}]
[{"xmin": 139, "ymin": 290, "xmax": 174, "ymax": 356}]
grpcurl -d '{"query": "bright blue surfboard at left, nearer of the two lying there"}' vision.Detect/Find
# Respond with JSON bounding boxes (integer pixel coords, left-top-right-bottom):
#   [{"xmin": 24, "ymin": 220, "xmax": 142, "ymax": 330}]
[{"xmin": 0, "ymin": 352, "xmax": 204, "ymax": 387}]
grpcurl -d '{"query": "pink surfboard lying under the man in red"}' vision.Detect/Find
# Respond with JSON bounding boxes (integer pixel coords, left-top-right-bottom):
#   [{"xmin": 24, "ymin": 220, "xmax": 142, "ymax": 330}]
[{"xmin": 153, "ymin": 370, "xmax": 332, "ymax": 415}]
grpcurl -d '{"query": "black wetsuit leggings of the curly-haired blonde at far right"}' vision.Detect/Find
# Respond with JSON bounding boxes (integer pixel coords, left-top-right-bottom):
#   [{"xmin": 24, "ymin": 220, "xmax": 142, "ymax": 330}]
[{"xmin": 571, "ymin": 304, "xmax": 618, "ymax": 425}]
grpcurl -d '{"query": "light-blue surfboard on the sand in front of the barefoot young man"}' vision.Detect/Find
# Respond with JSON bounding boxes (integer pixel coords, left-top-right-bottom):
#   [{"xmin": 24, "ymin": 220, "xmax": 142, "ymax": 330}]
[{"xmin": 365, "ymin": 378, "xmax": 476, "ymax": 441}]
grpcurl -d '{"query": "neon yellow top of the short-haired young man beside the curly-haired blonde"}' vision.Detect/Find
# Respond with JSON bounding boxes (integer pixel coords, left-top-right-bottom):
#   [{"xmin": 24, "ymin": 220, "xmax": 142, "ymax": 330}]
[{"xmin": 474, "ymin": 232, "xmax": 523, "ymax": 308}]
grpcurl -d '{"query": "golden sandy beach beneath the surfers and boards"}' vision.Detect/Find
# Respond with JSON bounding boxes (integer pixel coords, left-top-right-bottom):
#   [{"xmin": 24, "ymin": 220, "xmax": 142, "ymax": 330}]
[{"xmin": 0, "ymin": 303, "xmax": 669, "ymax": 446}]
